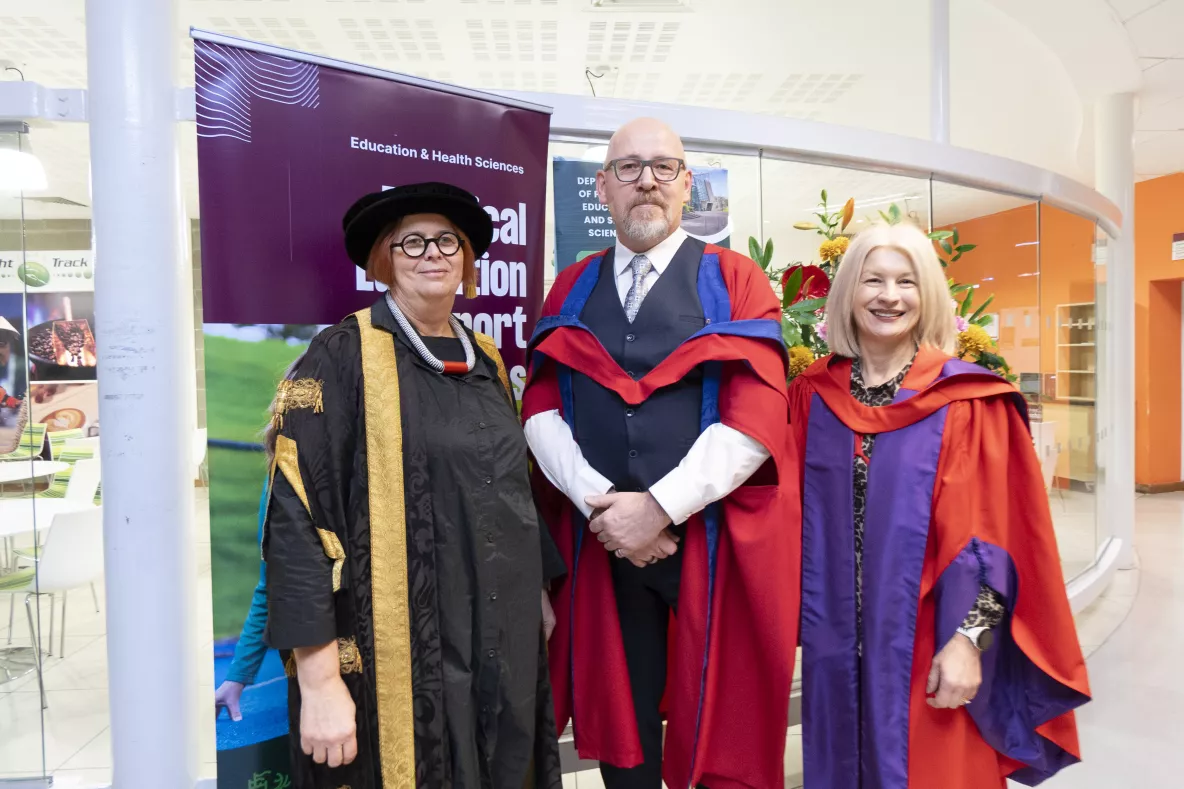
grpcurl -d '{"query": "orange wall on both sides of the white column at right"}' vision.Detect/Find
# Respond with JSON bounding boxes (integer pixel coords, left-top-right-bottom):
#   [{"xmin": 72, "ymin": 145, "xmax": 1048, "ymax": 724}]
[{"xmin": 950, "ymin": 173, "xmax": 1184, "ymax": 485}]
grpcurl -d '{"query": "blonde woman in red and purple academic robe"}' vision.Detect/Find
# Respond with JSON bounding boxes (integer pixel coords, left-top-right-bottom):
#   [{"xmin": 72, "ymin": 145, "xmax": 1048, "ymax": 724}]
[{"xmin": 790, "ymin": 224, "xmax": 1089, "ymax": 789}]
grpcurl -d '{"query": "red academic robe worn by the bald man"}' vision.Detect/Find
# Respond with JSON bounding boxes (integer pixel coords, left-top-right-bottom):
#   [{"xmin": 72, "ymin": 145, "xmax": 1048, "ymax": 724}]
[{"xmin": 522, "ymin": 245, "xmax": 800, "ymax": 789}]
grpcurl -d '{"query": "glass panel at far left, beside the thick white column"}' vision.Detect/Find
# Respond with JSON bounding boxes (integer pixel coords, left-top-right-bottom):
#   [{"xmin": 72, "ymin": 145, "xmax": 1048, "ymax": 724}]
[{"xmin": 0, "ymin": 118, "xmax": 110, "ymax": 787}]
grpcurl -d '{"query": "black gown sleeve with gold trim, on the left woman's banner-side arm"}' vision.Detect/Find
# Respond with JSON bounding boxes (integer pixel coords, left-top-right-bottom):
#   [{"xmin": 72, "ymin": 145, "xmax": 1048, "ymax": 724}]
[{"xmin": 263, "ymin": 325, "xmax": 360, "ymax": 649}]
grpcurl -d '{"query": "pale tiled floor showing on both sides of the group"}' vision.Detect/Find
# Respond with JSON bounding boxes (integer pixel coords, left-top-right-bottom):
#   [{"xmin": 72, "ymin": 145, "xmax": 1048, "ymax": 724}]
[{"xmin": 0, "ymin": 492, "xmax": 1150, "ymax": 789}]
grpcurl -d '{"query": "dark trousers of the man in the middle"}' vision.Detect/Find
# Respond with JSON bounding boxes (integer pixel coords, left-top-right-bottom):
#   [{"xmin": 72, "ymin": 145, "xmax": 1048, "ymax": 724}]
[{"xmin": 600, "ymin": 544, "xmax": 682, "ymax": 789}]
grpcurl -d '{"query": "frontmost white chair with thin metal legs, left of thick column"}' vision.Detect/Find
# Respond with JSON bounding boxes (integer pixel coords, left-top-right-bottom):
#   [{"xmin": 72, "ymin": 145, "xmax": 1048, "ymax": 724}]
[{"xmin": 0, "ymin": 507, "xmax": 103, "ymax": 710}]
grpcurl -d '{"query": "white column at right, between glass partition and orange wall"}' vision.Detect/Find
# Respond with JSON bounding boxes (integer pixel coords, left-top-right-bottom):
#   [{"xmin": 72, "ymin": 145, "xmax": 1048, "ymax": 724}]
[{"xmin": 1094, "ymin": 94, "xmax": 1134, "ymax": 569}]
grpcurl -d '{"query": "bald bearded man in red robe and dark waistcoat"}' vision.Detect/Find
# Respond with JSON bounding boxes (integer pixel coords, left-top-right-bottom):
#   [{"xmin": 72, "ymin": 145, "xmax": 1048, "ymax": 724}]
[{"xmin": 523, "ymin": 120, "xmax": 799, "ymax": 789}]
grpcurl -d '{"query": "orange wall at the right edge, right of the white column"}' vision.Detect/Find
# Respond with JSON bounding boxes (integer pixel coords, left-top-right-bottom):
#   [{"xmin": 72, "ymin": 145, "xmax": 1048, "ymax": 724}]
[{"xmin": 1134, "ymin": 173, "xmax": 1184, "ymax": 485}]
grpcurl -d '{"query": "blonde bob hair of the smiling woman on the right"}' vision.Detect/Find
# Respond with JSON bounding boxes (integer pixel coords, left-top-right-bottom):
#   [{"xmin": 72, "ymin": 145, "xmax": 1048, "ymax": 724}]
[{"xmin": 826, "ymin": 223, "xmax": 955, "ymax": 358}]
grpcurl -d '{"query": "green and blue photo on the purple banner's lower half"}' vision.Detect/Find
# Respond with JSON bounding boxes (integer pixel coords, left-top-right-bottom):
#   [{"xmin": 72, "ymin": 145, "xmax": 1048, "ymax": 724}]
[{"xmin": 202, "ymin": 323, "xmax": 323, "ymax": 751}]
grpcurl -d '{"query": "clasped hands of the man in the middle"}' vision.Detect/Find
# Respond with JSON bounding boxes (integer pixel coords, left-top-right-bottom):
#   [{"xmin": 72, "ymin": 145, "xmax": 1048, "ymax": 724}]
[{"xmin": 585, "ymin": 493, "xmax": 678, "ymax": 567}]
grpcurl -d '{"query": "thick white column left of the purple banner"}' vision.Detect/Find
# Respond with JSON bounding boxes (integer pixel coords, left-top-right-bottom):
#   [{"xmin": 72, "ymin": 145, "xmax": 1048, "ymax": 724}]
[{"xmin": 86, "ymin": 0, "xmax": 198, "ymax": 789}]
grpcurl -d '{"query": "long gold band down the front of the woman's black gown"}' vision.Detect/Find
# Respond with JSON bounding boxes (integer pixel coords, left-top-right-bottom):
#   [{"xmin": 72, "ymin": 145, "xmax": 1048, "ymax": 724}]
[{"xmin": 356, "ymin": 308, "xmax": 416, "ymax": 789}]
